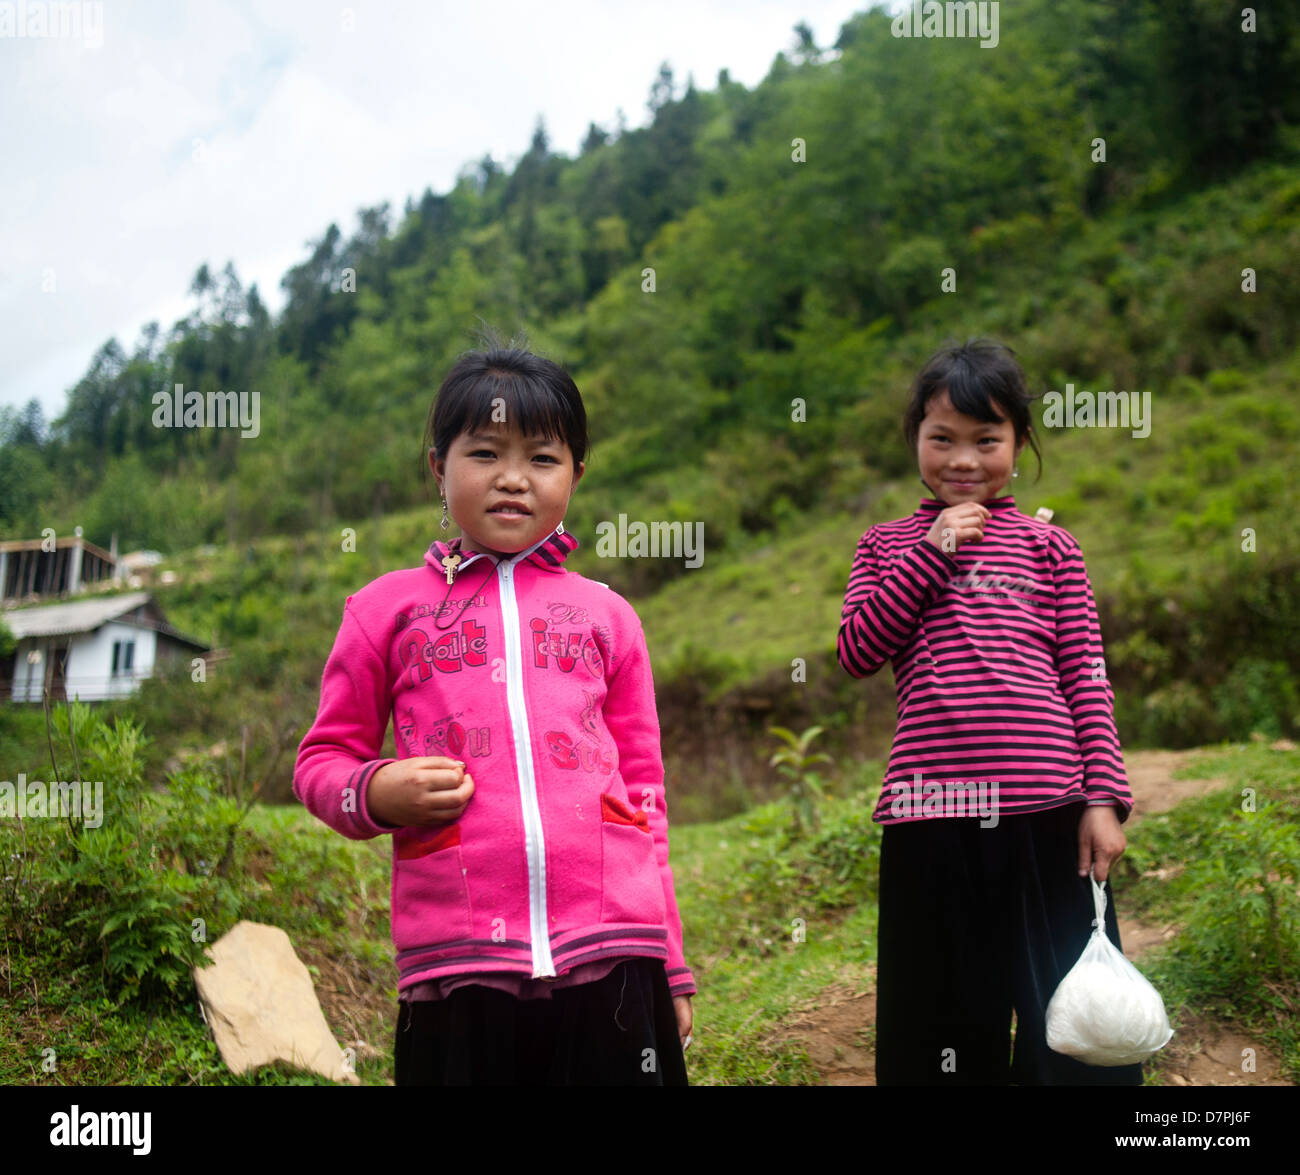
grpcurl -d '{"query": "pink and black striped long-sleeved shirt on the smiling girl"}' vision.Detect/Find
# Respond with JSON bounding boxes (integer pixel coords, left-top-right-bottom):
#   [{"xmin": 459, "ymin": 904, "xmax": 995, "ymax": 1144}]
[{"xmin": 839, "ymin": 497, "xmax": 1132, "ymax": 824}]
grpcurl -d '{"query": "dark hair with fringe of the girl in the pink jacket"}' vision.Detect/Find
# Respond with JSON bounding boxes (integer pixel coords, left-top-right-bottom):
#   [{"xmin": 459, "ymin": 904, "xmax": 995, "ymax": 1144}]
[{"xmin": 424, "ymin": 334, "xmax": 588, "ymax": 480}]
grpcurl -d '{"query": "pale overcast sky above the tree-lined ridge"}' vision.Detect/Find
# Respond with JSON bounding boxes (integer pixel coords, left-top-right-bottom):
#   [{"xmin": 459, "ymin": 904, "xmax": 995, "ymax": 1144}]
[{"xmin": 0, "ymin": 0, "xmax": 870, "ymax": 420}]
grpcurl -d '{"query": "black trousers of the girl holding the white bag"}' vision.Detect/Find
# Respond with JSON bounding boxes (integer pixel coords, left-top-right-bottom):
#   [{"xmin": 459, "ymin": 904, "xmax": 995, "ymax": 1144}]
[{"xmin": 876, "ymin": 803, "xmax": 1141, "ymax": 1085}]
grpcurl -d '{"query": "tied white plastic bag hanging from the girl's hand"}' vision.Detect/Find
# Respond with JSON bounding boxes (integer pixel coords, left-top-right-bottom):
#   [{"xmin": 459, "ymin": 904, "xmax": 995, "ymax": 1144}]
[{"xmin": 1048, "ymin": 873, "xmax": 1174, "ymax": 1066}]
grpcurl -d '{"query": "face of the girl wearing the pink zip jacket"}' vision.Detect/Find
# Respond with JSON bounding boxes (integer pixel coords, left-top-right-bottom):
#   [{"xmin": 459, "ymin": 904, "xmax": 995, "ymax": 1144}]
[{"xmin": 429, "ymin": 422, "xmax": 586, "ymax": 558}]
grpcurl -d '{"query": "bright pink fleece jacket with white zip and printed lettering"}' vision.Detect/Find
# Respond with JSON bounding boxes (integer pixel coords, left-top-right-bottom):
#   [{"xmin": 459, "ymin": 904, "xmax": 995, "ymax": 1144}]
[{"xmin": 294, "ymin": 532, "xmax": 696, "ymax": 996}]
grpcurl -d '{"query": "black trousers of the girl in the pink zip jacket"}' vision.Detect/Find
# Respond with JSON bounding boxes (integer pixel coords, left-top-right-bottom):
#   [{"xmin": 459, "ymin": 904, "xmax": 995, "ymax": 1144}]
[{"xmin": 393, "ymin": 959, "xmax": 686, "ymax": 1085}]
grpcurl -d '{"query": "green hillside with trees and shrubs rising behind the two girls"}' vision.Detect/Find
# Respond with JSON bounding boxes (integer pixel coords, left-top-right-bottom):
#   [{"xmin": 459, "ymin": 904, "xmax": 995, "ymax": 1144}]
[{"xmin": 0, "ymin": 0, "xmax": 1300, "ymax": 814}]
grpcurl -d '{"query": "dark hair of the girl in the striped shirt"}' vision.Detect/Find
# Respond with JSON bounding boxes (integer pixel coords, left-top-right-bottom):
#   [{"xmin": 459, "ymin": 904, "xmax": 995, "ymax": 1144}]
[{"xmin": 902, "ymin": 339, "xmax": 1043, "ymax": 481}]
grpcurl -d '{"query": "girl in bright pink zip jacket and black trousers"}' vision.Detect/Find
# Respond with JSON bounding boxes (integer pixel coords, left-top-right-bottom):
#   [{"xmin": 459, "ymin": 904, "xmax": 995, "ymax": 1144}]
[{"xmin": 294, "ymin": 348, "xmax": 696, "ymax": 1085}]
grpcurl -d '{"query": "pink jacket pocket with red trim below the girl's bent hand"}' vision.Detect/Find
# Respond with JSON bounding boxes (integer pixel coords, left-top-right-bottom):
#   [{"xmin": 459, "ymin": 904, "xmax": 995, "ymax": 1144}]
[{"xmin": 393, "ymin": 823, "xmax": 473, "ymax": 948}]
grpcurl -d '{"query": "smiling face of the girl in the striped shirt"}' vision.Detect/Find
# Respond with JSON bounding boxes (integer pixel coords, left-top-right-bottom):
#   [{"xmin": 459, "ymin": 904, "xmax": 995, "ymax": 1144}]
[{"xmin": 917, "ymin": 387, "xmax": 1028, "ymax": 506}]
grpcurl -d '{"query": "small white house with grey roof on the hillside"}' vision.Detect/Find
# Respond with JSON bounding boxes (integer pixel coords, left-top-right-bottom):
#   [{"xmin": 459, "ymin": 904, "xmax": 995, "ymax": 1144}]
[{"xmin": 0, "ymin": 591, "xmax": 209, "ymax": 702}]
